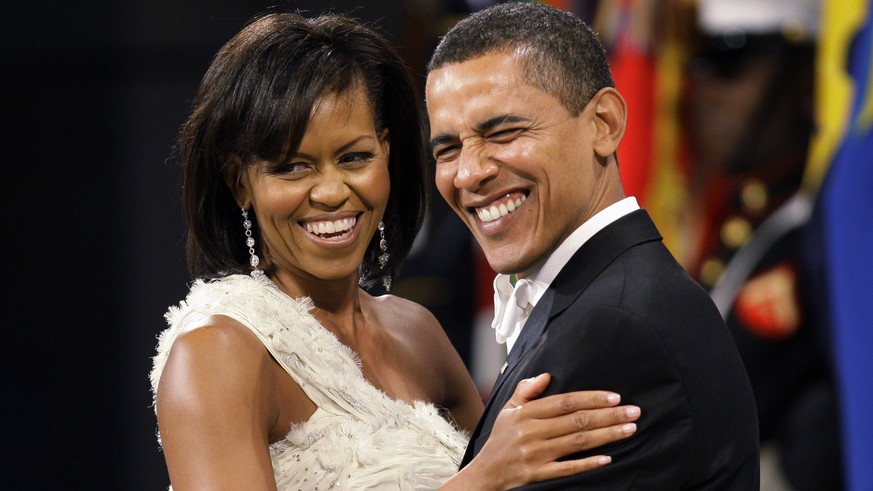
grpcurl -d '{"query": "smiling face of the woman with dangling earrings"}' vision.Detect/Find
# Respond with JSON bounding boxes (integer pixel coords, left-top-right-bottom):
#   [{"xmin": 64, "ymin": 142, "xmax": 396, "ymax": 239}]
[{"xmin": 227, "ymin": 86, "xmax": 392, "ymax": 290}]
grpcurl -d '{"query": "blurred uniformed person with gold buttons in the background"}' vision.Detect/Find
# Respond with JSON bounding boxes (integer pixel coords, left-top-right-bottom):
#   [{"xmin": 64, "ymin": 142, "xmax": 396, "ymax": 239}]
[{"xmin": 683, "ymin": 0, "xmax": 843, "ymax": 491}]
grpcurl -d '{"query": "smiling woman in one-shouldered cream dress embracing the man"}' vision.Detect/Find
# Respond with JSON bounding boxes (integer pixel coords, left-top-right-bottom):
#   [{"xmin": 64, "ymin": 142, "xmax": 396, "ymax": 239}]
[{"xmin": 151, "ymin": 8, "xmax": 639, "ymax": 491}]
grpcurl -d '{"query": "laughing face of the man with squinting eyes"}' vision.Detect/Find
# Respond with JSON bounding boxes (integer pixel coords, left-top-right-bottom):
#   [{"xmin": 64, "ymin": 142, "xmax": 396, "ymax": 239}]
[{"xmin": 426, "ymin": 53, "xmax": 603, "ymax": 277}]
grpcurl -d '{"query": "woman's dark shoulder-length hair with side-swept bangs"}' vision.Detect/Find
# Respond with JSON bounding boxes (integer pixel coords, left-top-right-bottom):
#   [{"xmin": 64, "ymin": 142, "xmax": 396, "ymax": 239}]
[{"xmin": 176, "ymin": 13, "xmax": 428, "ymax": 281}]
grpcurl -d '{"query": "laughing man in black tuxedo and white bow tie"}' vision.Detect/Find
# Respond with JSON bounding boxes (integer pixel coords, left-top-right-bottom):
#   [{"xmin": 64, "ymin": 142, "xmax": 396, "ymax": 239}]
[{"xmin": 426, "ymin": 3, "xmax": 759, "ymax": 490}]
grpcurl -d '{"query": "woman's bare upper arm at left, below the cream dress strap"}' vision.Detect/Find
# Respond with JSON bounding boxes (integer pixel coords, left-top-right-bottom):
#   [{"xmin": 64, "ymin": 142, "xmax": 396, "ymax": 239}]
[{"xmin": 156, "ymin": 316, "xmax": 276, "ymax": 491}]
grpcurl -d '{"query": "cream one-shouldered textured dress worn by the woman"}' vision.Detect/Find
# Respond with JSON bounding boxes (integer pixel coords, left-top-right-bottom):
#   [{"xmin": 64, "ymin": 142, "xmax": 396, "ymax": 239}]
[{"xmin": 151, "ymin": 275, "xmax": 467, "ymax": 490}]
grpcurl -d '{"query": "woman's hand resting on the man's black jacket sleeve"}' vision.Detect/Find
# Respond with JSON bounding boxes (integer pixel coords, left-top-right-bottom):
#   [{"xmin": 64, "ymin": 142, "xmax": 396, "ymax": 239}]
[{"xmin": 445, "ymin": 374, "xmax": 640, "ymax": 490}]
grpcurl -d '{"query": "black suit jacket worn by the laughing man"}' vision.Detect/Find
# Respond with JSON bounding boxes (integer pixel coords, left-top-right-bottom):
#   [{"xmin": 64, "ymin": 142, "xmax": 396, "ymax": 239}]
[{"xmin": 462, "ymin": 210, "xmax": 759, "ymax": 491}]
